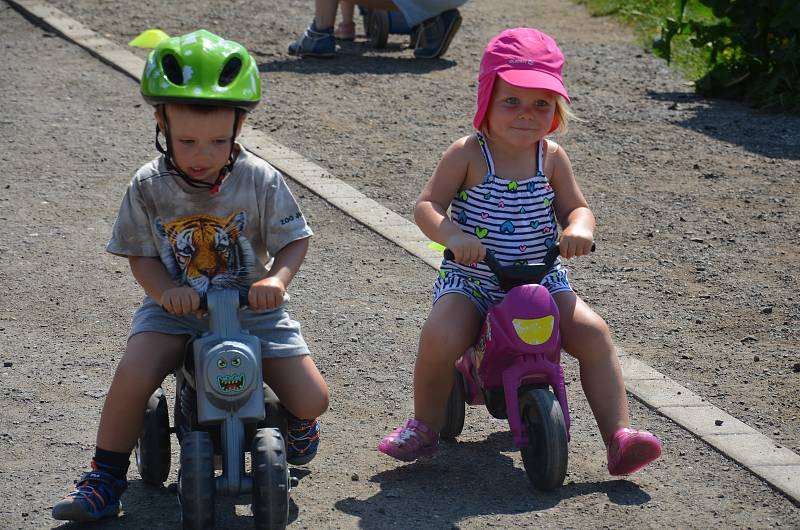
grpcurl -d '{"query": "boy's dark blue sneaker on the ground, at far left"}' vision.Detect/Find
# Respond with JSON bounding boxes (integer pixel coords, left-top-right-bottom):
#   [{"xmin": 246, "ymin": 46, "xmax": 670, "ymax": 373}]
[{"xmin": 53, "ymin": 471, "xmax": 128, "ymax": 522}]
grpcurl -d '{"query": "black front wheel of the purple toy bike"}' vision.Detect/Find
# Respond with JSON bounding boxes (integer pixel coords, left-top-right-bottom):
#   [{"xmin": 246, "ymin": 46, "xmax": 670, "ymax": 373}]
[{"xmin": 520, "ymin": 388, "xmax": 567, "ymax": 491}]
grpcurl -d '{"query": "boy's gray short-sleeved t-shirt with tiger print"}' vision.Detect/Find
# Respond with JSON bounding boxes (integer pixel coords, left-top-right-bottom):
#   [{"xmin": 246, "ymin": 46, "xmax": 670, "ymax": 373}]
[{"xmin": 106, "ymin": 146, "xmax": 312, "ymax": 294}]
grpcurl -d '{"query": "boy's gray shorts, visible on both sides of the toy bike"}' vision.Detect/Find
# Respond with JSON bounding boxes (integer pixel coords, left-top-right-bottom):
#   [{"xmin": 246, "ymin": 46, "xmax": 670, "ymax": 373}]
[{"xmin": 128, "ymin": 296, "xmax": 310, "ymax": 359}]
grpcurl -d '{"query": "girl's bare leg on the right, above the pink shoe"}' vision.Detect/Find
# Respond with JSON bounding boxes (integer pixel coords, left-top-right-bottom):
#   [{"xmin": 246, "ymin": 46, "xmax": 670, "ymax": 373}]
[{"xmin": 553, "ymin": 292, "xmax": 630, "ymax": 444}]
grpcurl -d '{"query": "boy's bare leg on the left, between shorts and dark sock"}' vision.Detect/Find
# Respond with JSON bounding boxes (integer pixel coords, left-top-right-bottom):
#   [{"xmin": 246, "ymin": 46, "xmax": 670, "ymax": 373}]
[{"xmin": 97, "ymin": 332, "xmax": 188, "ymax": 453}]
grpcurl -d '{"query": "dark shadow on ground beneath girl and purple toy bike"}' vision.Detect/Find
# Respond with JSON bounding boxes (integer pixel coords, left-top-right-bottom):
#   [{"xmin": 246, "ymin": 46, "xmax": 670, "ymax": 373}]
[{"xmin": 336, "ymin": 433, "xmax": 650, "ymax": 530}]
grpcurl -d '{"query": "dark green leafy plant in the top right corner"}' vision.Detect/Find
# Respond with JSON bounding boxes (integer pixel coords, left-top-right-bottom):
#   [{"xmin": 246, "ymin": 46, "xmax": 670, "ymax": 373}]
[{"xmin": 653, "ymin": 0, "xmax": 800, "ymax": 111}]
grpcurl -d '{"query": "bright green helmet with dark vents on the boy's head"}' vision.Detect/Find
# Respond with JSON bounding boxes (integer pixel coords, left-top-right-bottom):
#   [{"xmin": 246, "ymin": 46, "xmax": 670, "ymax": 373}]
[{"xmin": 141, "ymin": 29, "xmax": 261, "ymax": 111}]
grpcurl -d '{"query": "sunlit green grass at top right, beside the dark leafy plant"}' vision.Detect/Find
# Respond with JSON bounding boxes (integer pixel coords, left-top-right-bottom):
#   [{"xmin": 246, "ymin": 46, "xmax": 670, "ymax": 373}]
[{"xmin": 575, "ymin": 0, "xmax": 715, "ymax": 80}]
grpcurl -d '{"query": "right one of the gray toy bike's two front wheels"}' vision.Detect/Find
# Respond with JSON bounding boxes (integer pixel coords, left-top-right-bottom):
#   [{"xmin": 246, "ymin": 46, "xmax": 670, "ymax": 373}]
[{"xmin": 251, "ymin": 428, "xmax": 290, "ymax": 530}]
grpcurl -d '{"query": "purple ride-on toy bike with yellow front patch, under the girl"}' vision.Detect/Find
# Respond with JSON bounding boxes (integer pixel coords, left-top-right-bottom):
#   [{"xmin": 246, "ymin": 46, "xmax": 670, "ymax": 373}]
[{"xmin": 440, "ymin": 241, "xmax": 594, "ymax": 490}]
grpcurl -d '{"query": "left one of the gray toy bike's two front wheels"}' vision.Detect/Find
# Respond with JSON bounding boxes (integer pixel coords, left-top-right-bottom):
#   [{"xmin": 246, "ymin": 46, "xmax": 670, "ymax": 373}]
[{"xmin": 178, "ymin": 431, "xmax": 216, "ymax": 530}]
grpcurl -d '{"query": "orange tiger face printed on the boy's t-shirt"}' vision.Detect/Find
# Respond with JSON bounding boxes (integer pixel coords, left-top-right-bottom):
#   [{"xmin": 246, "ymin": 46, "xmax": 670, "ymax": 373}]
[{"xmin": 153, "ymin": 212, "xmax": 257, "ymax": 294}]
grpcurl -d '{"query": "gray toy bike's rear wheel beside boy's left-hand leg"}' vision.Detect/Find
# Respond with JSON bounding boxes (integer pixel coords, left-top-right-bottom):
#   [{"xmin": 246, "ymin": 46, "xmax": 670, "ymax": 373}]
[{"xmin": 135, "ymin": 388, "xmax": 172, "ymax": 486}]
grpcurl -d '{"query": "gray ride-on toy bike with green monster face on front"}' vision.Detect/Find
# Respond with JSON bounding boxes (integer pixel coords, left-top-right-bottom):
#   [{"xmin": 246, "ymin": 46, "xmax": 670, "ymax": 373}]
[{"xmin": 136, "ymin": 289, "xmax": 296, "ymax": 530}]
